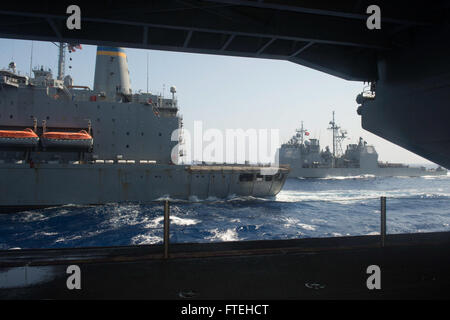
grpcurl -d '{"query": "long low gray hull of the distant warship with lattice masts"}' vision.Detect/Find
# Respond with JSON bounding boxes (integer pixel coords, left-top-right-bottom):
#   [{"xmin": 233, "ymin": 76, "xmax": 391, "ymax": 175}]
[{"xmin": 289, "ymin": 167, "xmax": 447, "ymax": 178}]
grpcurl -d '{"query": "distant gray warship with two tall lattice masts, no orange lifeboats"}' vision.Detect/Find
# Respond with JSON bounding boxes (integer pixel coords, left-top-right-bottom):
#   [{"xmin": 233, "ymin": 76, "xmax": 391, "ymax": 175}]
[{"xmin": 279, "ymin": 112, "xmax": 447, "ymax": 178}]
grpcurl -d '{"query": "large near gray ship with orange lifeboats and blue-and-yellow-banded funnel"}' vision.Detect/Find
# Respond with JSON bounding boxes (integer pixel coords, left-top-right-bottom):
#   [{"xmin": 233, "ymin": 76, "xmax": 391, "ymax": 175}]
[{"xmin": 0, "ymin": 43, "xmax": 289, "ymax": 212}]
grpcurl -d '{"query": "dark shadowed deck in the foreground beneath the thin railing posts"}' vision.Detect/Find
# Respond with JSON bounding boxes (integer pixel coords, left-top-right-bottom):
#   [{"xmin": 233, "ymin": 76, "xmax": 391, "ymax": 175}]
[{"xmin": 0, "ymin": 232, "xmax": 450, "ymax": 299}]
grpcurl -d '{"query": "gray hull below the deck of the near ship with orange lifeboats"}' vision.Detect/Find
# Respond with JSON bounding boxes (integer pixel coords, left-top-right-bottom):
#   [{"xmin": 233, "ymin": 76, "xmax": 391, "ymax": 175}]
[{"xmin": 0, "ymin": 163, "xmax": 288, "ymax": 211}]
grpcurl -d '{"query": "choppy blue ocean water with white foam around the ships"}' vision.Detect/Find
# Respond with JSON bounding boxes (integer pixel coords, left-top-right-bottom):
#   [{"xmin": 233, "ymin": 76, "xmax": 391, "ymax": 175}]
[{"xmin": 0, "ymin": 172, "xmax": 450, "ymax": 249}]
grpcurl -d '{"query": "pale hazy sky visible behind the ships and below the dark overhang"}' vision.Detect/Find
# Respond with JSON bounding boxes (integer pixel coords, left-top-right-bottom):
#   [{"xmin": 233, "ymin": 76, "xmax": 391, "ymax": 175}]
[{"xmin": 0, "ymin": 39, "xmax": 436, "ymax": 164}]
